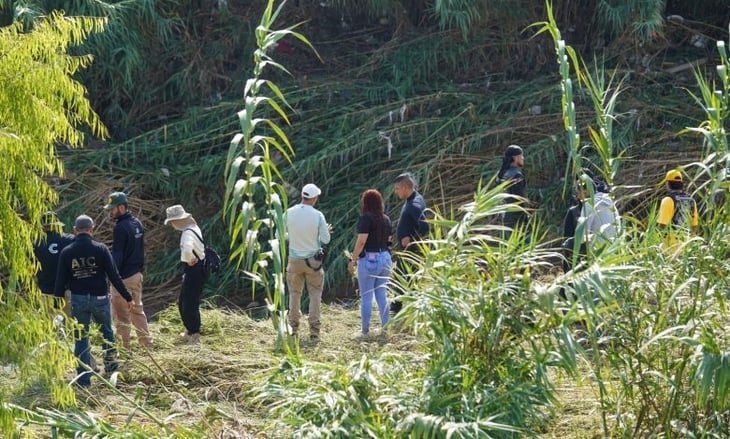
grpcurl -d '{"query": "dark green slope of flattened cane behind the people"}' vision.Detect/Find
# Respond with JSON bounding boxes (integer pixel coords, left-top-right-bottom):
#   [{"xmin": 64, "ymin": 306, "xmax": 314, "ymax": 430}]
[{"xmin": 48, "ymin": 1, "xmax": 725, "ymax": 309}]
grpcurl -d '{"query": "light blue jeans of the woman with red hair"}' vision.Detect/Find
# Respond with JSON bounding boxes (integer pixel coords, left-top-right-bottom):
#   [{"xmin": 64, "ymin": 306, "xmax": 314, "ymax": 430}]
[{"xmin": 357, "ymin": 251, "xmax": 393, "ymax": 334}]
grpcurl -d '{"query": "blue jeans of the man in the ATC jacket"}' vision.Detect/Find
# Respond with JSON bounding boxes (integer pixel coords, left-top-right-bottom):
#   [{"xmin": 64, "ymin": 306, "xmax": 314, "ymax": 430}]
[{"xmin": 71, "ymin": 294, "xmax": 117, "ymax": 386}]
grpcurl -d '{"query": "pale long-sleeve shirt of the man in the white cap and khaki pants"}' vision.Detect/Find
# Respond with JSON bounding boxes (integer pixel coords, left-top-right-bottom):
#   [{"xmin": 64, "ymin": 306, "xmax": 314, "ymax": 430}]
[{"xmin": 286, "ymin": 204, "xmax": 331, "ymax": 259}]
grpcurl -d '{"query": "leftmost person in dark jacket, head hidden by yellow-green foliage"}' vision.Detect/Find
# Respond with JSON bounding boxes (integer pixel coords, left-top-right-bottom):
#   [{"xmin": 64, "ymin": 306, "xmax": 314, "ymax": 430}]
[{"xmin": 33, "ymin": 212, "xmax": 74, "ymax": 315}]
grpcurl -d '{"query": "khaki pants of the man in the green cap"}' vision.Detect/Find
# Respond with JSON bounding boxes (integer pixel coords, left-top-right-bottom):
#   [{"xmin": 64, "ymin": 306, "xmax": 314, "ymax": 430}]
[{"xmin": 111, "ymin": 273, "xmax": 152, "ymax": 349}]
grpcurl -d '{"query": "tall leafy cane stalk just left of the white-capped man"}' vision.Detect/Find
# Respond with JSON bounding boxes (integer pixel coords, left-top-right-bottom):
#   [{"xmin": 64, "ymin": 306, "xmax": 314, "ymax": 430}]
[{"xmin": 224, "ymin": 0, "xmax": 314, "ymax": 350}]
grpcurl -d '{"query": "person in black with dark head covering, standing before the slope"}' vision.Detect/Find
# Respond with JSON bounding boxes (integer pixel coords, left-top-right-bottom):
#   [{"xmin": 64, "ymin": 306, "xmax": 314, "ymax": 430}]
[{"xmin": 497, "ymin": 145, "xmax": 529, "ymax": 242}]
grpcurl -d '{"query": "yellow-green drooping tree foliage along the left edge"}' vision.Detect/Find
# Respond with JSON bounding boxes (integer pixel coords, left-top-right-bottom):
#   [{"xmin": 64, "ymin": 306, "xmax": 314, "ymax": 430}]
[{"xmin": 0, "ymin": 14, "xmax": 106, "ymax": 433}]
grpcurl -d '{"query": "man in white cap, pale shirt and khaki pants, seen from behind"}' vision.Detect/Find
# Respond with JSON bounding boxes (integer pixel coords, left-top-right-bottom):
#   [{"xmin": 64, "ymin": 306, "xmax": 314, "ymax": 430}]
[{"xmin": 286, "ymin": 183, "xmax": 331, "ymax": 342}]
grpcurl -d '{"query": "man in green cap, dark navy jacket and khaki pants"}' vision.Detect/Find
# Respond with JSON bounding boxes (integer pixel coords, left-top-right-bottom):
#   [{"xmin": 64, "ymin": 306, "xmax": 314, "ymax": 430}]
[{"xmin": 104, "ymin": 192, "xmax": 152, "ymax": 350}]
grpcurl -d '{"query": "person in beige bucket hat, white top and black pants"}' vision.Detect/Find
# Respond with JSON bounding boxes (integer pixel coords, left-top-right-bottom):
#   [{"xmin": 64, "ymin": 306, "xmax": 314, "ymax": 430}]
[{"xmin": 165, "ymin": 204, "xmax": 206, "ymax": 344}]
